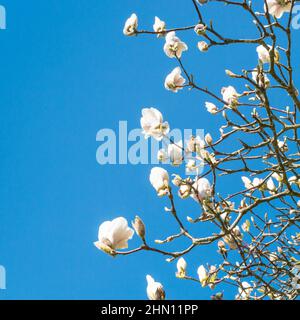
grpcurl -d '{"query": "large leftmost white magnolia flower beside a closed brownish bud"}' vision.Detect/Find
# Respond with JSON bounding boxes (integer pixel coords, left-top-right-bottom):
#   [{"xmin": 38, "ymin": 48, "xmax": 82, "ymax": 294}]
[{"xmin": 94, "ymin": 217, "xmax": 134, "ymax": 253}]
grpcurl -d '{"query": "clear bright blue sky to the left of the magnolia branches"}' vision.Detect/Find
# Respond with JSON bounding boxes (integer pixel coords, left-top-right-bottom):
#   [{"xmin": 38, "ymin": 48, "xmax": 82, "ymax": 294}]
[{"xmin": 0, "ymin": 0, "xmax": 300, "ymax": 299}]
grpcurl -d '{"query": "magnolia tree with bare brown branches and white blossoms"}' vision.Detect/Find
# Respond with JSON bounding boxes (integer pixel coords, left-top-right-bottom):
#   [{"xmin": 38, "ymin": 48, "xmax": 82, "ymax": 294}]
[{"xmin": 95, "ymin": 0, "xmax": 300, "ymax": 300}]
